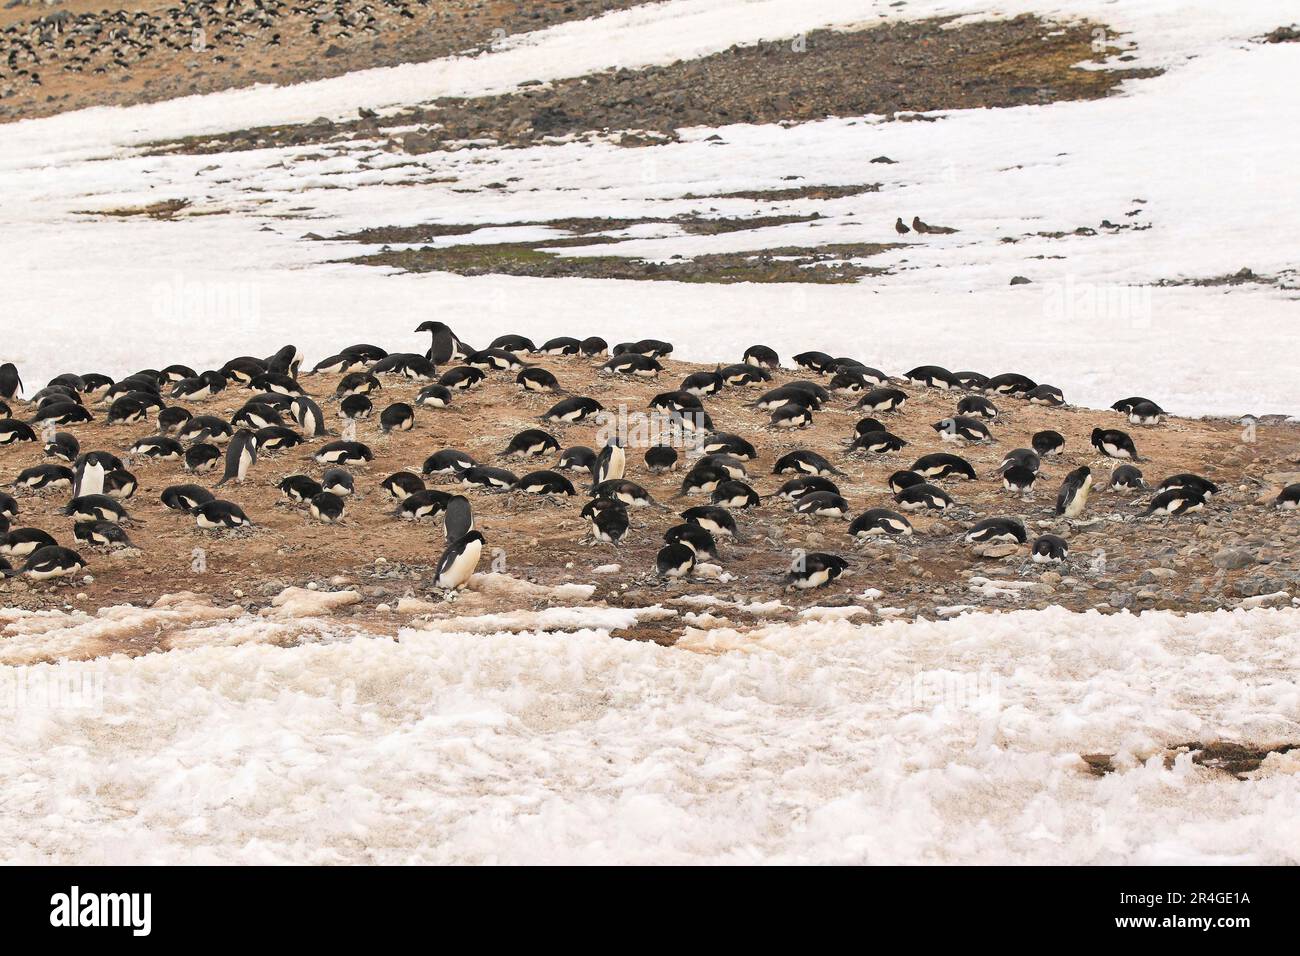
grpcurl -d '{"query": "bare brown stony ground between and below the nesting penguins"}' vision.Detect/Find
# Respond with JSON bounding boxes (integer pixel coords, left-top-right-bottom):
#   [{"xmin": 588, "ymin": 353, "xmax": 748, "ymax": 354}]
[{"xmin": 0, "ymin": 343, "xmax": 1300, "ymax": 650}]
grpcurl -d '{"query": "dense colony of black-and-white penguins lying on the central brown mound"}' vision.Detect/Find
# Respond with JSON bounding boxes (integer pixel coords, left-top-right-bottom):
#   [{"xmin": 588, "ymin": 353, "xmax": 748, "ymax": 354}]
[{"xmin": 0, "ymin": 332, "xmax": 1300, "ymax": 592}]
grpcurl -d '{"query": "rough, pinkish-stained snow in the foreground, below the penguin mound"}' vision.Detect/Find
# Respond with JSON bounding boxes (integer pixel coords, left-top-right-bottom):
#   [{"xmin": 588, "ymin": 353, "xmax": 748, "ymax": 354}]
[{"xmin": 0, "ymin": 610, "xmax": 1300, "ymax": 864}]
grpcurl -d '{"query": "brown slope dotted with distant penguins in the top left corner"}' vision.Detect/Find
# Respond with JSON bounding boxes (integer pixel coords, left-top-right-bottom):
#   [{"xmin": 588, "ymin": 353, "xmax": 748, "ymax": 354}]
[{"xmin": 0, "ymin": 0, "xmax": 647, "ymax": 122}]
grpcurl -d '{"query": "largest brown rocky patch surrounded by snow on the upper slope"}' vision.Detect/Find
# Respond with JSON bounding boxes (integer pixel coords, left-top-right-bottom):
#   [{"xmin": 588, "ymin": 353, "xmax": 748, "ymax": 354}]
[{"xmin": 142, "ymin": 16, "xmax": 1154, "ymax": 153}]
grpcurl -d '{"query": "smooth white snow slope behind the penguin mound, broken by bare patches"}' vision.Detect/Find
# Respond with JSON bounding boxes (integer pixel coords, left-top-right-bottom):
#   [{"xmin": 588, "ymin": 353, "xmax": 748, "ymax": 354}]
[{"xmin": 0, "ymin": 0, "xmax": 1300, "ymax": 415}]
